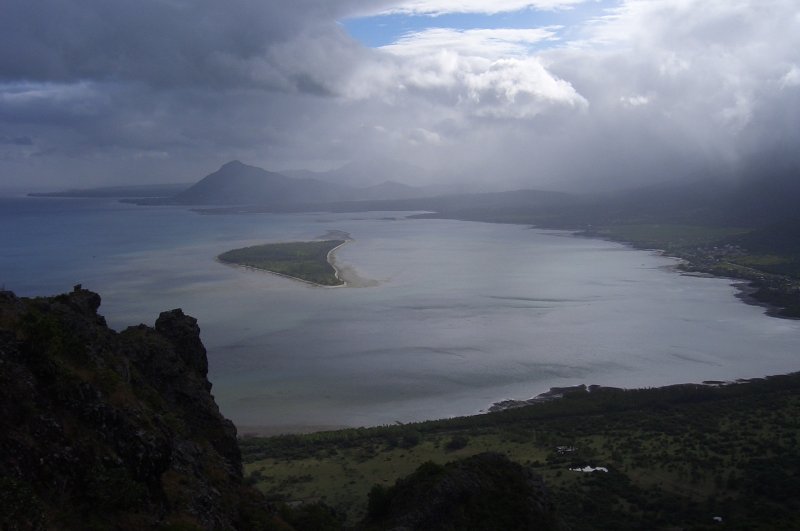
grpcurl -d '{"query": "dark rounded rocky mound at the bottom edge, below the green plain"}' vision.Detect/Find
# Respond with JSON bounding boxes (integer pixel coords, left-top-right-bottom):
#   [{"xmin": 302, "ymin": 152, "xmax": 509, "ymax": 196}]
[{"xmin": 362, "ymin": 453, "xmax": 565, "ymax": 531}]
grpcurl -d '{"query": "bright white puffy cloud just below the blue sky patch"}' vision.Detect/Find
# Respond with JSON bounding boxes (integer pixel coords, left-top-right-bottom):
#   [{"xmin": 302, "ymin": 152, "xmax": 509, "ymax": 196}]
[{"xmin": 349, "ymin": 28, "xmax": 586, "ymax": 119}]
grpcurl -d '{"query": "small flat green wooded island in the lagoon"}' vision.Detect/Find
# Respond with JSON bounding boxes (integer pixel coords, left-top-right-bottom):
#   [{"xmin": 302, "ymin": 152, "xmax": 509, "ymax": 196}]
[{"xmin": 218, "ymin": 240, "xmax": 346, "ymax": 286}]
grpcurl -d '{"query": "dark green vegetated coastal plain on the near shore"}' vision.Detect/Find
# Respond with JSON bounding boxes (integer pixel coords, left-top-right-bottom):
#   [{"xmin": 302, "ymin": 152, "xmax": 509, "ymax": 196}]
[{"xmin": 240, "ymin": 374, "xmax": 800, "ymax": 529}]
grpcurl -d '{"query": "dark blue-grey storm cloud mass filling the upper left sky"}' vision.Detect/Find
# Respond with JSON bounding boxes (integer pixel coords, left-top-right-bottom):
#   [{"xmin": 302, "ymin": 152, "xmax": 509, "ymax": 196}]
[{"xmin": 0, "ymin": 0, "xmax": 378, "ymax": 186}]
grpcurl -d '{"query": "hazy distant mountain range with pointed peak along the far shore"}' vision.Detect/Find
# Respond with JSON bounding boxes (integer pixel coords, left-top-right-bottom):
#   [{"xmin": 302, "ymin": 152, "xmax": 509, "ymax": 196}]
[{"xmin": 26, "ymin": 161, "xmax": 800, "ymax": 233}]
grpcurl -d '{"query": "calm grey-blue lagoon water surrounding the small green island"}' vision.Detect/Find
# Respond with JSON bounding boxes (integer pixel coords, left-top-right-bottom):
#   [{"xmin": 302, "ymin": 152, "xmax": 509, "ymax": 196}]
[{"xmin": 0, "ymin": 198, "xmax": 800, "ymax": 429}]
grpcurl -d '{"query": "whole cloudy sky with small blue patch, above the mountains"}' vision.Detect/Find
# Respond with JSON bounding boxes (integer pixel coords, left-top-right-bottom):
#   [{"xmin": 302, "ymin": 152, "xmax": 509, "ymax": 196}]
[{"xmin": 0, "ymin": 0, "xmax": 800, "ymax": 190}]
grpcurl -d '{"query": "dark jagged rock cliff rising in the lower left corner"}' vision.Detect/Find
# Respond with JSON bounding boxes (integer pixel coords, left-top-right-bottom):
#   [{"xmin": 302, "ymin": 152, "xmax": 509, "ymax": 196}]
[{"xmin": 0, "ymin": 286, "xmax": 270, "ymax": 529}]
